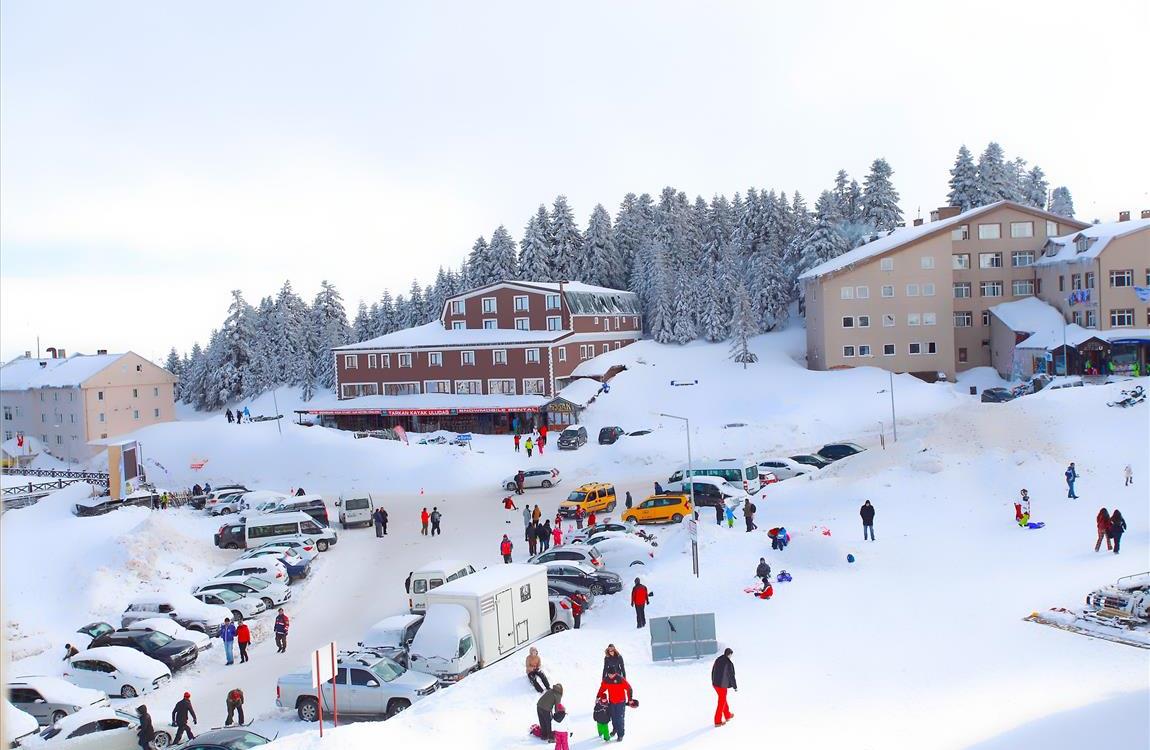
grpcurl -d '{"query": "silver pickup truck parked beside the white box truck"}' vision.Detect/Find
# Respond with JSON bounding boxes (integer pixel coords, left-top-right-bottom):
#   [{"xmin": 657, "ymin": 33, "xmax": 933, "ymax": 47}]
[{"xmin": 276, "ymin": 651, "xmax": 439, "ymax": 721}]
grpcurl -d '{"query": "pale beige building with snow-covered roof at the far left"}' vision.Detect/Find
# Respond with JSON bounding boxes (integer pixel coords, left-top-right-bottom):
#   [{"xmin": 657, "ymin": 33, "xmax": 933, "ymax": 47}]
[{"xmin": 0, "ymin": 349, "xmax": 176, "ymax": 461}]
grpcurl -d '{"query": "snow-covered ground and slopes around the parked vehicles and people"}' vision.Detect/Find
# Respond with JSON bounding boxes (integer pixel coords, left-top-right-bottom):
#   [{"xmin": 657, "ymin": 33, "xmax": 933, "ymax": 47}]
[{"xmin": 2, "ymin": 330, "xmax": 1150, "ymax": 749}]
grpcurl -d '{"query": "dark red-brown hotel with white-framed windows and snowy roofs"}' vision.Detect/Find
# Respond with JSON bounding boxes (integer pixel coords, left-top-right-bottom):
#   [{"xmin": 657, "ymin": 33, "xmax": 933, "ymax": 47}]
[{"xmin": 309, "ymin": 281, "xmax": 643, "ymax": 433}]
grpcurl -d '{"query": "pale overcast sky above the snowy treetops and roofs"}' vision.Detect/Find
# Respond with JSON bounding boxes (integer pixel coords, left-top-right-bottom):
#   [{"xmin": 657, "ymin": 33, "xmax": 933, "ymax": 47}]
[{"xmin": 0, "ymin": 0, "xmax": 1150, "ymax": 359}]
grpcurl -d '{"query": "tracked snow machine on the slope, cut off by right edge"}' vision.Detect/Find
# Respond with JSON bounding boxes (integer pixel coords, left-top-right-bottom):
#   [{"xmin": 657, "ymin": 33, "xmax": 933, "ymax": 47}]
[{"xmin": 1025, "ymin": 572, "xmax": 1150, "ymax": 649}]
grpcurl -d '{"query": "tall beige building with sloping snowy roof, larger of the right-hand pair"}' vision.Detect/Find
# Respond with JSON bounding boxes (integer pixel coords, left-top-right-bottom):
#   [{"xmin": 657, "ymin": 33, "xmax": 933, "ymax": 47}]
[{"xmin": 799, "ymin": 201, "xmax": 1087, "ymax": 380}]
